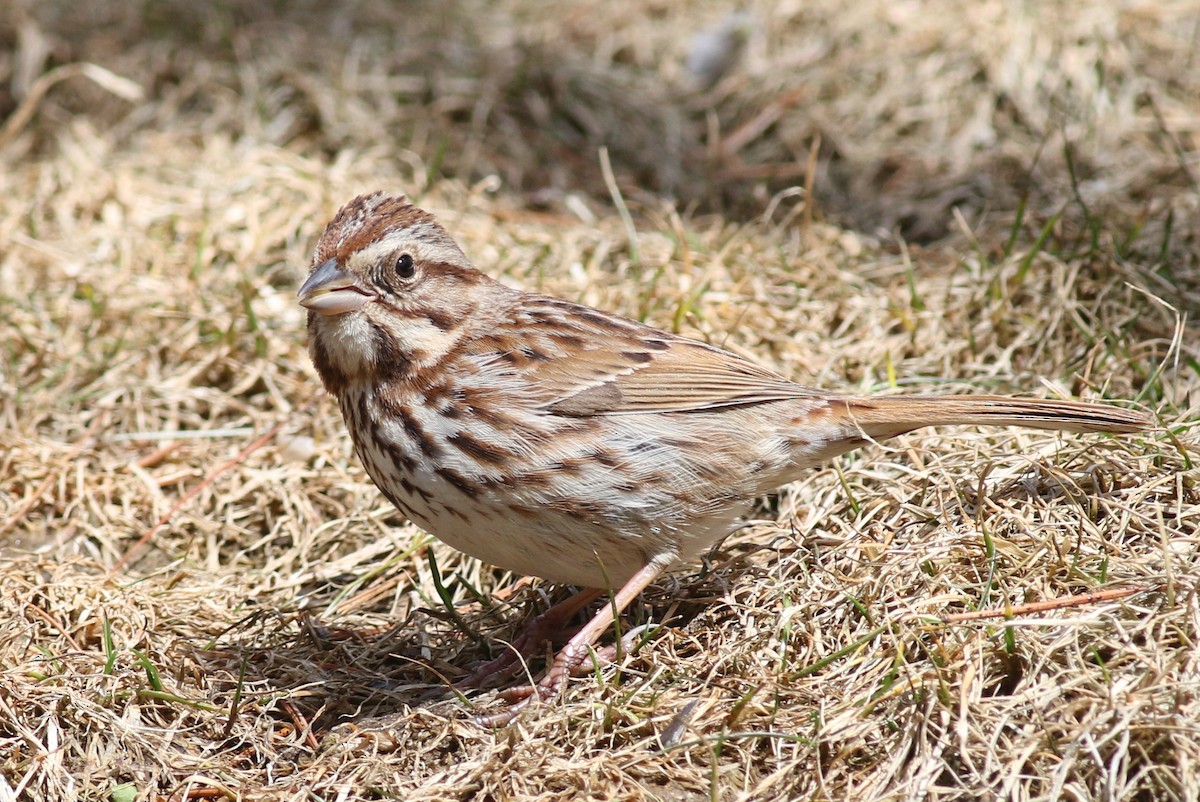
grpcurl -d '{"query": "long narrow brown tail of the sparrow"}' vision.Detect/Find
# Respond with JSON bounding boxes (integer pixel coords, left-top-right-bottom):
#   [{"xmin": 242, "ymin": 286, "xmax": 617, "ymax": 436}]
[{"xmin": 833, "ymin": 395, "xmax": 1151, "ymax": 438}]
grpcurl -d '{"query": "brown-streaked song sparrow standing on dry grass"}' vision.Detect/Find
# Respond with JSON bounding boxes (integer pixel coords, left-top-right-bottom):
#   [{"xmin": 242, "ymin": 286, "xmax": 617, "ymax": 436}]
[{"xmin": 300, "ymin": 193, "xmax": 1148, "ymax": 724}]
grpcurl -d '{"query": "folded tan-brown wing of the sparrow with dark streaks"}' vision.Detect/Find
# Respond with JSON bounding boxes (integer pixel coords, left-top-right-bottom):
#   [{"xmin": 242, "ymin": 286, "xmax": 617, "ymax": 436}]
[{"xmin": 460, "ymin": 297, "xmax": 816, "ymax": 417}]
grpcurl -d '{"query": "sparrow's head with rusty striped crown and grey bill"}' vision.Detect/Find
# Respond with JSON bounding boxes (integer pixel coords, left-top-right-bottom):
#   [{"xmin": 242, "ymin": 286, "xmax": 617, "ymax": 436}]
[{"xmin": 300, "ymin": 192, "xmax": 490, "ymax": 393}]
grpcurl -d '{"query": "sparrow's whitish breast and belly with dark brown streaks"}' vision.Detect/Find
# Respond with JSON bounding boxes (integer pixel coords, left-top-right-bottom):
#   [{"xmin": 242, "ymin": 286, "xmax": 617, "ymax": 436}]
[{"xmin": 343, "ymin": 384, "xmax": 750, "ymax": 588}]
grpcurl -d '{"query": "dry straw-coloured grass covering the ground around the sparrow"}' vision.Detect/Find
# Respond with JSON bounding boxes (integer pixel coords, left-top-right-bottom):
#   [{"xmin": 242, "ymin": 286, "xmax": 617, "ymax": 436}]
[{"xmin": 0, "ymin": 0, "xmax": 1200, "ymax": 801}]
